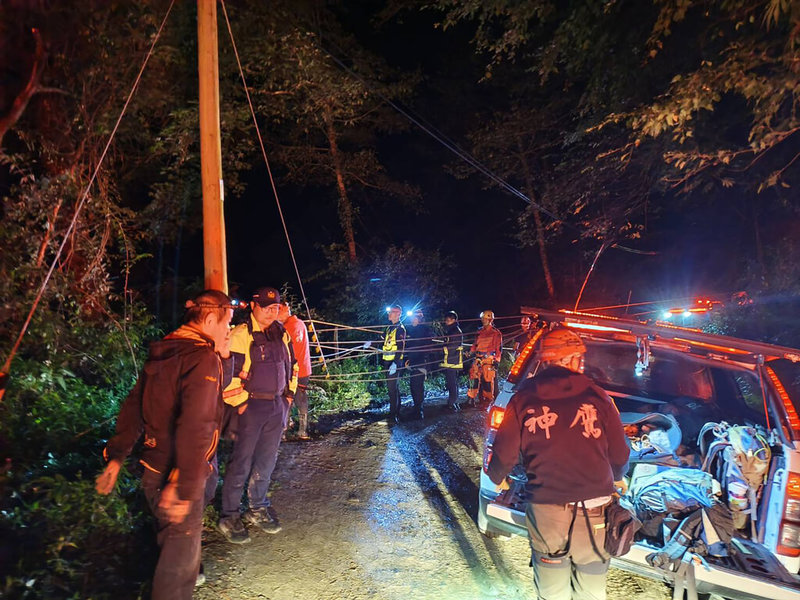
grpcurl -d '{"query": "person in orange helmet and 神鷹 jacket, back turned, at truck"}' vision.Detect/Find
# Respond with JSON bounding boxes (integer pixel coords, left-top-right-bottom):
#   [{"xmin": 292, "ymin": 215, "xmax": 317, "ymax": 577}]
[{"xmin": 487, "ymin": 328, "xmax": 629, "ymax": 600}]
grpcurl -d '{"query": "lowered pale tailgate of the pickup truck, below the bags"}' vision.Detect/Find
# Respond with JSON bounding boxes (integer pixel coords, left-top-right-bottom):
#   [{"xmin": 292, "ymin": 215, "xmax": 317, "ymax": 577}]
[{"xmin": 486, "ymin": 502, "xmax": 800, "ymax": 600}]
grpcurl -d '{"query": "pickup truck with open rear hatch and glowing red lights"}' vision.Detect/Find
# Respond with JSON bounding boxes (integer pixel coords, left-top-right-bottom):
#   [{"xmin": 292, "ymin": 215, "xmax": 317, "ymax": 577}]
[{"xmin": 477, "ymin": 307, "xmax": 800, "ymax": 600}]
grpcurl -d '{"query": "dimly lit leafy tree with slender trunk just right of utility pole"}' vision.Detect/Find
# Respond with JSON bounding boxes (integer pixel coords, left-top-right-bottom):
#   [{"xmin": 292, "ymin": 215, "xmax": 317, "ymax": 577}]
[{"xmin": 220, "ymin": 1, "xmax": 419, "ymax": 261}]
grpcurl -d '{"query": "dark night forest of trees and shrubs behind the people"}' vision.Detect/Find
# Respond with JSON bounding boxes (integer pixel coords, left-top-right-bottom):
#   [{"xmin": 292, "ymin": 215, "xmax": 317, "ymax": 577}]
[{"xmin": 0, "ymin": 0, "xmax": 800, "ymax": 598}]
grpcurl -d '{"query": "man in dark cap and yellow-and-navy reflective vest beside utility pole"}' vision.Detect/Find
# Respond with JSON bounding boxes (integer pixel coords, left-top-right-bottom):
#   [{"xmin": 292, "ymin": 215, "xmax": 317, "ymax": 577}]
[{"xmin": 218, "ymin": 287, "xmax": 298, "ymax": 544}]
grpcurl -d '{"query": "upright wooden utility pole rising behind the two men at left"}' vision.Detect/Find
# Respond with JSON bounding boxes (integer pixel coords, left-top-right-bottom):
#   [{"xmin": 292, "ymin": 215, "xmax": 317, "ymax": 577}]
[{"xmin": 197, "ymin": 0, "xmax": 228, "ymax": 294}]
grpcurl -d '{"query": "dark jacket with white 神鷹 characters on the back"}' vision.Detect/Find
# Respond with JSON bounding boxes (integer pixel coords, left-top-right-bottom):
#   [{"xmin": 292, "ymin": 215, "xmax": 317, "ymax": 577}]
[{"xmin": 488, "ymin": 366, "xmax": 629, "ymax": 504}]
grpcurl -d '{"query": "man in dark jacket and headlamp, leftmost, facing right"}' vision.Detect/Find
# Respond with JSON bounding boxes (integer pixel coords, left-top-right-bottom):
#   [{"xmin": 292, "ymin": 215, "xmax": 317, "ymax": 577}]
[{"xmin": 95, "ymin": 290, "xmax": 233, "ymax": 600}]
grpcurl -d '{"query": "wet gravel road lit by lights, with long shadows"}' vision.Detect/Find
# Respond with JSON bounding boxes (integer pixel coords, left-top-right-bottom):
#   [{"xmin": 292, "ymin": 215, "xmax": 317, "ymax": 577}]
[{"xmin": 195, "ymin": 404, "xmax": 671, "ymax": 600}]
